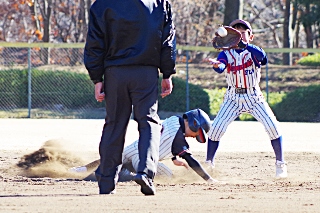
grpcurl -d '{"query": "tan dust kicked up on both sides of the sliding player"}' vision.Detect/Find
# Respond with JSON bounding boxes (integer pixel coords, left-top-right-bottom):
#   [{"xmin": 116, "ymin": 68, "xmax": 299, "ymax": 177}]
[{"xmin": 16, "ymin": 139, "xmax": 216, "ymax": 184}]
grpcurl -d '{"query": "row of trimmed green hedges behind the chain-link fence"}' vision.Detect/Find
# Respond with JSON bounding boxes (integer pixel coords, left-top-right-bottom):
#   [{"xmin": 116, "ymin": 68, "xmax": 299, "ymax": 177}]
[{"xmin": 0, "ymin": 69, "xmax": 320, "ymax": 122}]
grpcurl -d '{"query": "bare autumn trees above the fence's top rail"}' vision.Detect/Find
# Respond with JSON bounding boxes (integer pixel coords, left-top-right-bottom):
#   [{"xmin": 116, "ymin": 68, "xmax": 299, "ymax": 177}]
[{"xmin": 0, "ymin": 0, "xmax": 320, "ymax": 64}]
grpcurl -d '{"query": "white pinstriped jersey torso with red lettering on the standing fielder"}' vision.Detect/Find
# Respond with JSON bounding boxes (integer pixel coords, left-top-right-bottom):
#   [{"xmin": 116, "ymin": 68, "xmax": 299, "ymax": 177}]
[{"xmin": 225, "ymin": 49, "xmax": 261, "ymax": 88}]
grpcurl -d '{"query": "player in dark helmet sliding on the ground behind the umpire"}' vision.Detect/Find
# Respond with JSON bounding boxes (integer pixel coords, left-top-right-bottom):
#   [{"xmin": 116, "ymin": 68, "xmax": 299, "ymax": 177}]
[{"xmin": 70, "ymin": 109, "xmax": 217, "ymax": 183}]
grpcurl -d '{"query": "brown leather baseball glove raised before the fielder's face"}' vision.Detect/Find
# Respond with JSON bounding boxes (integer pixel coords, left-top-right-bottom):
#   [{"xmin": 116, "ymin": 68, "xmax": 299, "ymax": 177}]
[{"xmin": 212, "ymin": 26, "xmax": 241, "ymax": 50}]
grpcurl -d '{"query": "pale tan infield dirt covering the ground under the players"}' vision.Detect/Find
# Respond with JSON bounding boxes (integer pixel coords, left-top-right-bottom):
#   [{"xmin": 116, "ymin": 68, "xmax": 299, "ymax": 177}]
[{"xmin": 0, "ymin": 119, "xmax": 320, "ymax": 213}]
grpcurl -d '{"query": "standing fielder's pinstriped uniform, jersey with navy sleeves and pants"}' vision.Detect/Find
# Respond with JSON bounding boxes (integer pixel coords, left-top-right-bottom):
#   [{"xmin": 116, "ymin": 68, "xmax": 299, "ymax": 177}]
[{"xmin": 208, "ymin": 44, "xmax": 281, "ymax": 141}]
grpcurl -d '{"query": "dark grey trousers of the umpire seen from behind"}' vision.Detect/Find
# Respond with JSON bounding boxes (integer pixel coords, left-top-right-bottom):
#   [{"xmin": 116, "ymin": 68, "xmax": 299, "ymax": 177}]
[{"xmin": 96, "ymin": 66, "xmax": 161, "ymax": 194}]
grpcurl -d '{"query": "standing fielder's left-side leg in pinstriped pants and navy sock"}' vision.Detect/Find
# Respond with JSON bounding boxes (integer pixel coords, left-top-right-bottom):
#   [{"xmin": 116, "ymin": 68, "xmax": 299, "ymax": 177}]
[{"xmin": 206, "ymin": 99, "xmax": 241, "ymax": 164}]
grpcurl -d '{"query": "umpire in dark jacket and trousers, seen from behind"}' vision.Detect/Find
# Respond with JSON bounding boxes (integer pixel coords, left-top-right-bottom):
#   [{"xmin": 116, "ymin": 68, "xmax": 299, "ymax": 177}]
[{"xmin": 84, "ymin": 0, "xmax": 176, "ymax": 195}]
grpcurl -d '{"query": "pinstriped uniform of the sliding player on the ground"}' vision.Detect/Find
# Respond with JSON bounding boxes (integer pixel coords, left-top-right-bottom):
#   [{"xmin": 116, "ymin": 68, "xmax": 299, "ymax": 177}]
[{"xmin": 122, "ymin": 116, "xmax": 189, "ymax": 177}]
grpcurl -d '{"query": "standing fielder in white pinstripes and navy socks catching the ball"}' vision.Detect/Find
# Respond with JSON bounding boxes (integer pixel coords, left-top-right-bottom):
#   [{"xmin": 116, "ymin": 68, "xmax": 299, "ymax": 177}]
[{"xmin": 206, "ymin": 19, "xmax": 287, "ymax": 178}]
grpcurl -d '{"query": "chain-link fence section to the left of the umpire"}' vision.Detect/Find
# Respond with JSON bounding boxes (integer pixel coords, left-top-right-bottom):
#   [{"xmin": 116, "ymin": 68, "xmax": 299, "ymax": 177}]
[{"xmin": 0, "ymin": 47, "xmax": 105, "ymax": 118}]
